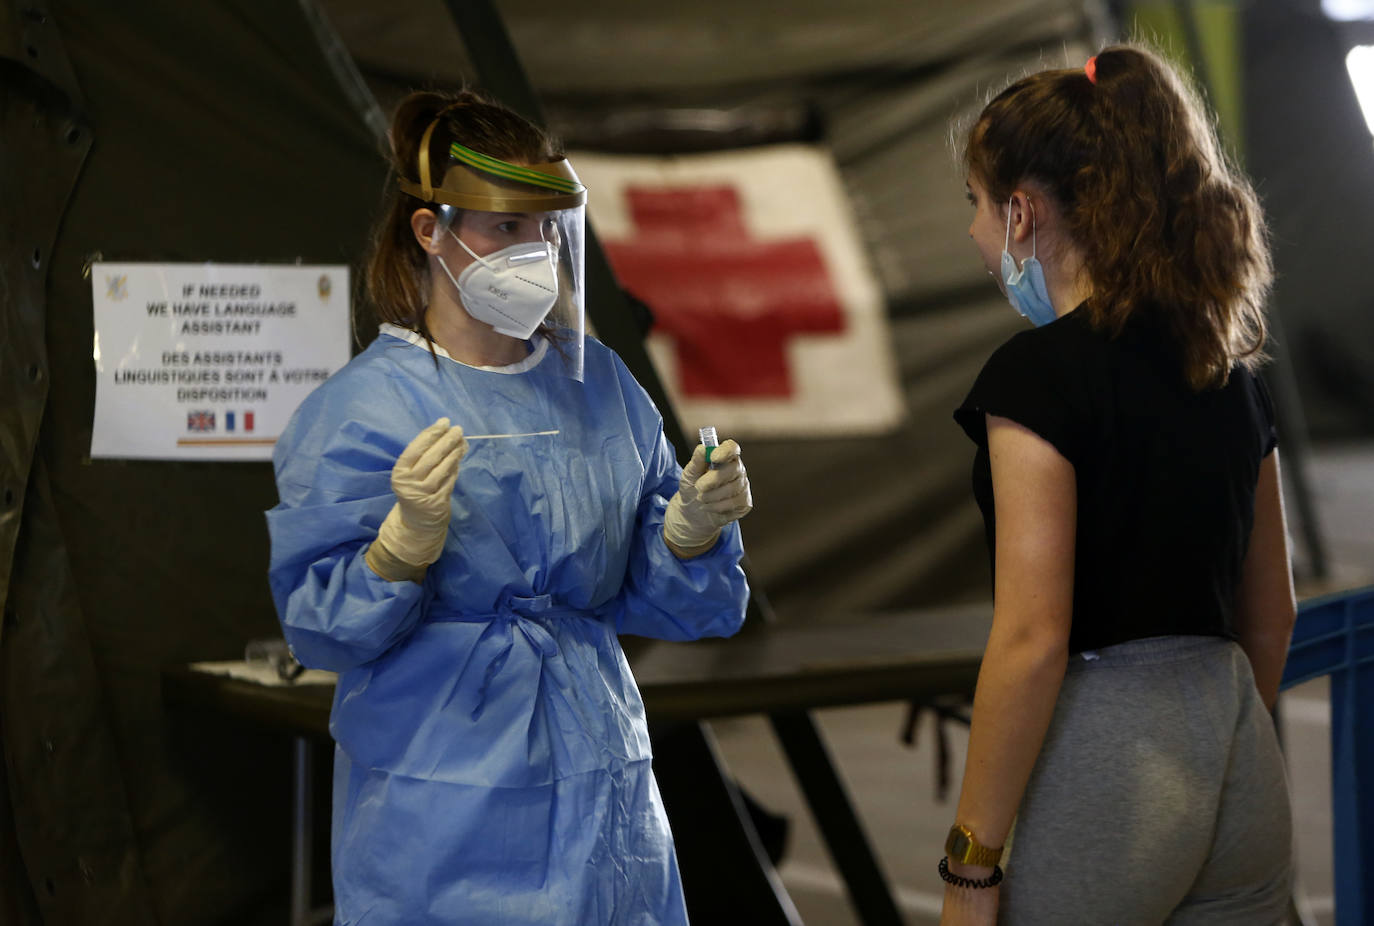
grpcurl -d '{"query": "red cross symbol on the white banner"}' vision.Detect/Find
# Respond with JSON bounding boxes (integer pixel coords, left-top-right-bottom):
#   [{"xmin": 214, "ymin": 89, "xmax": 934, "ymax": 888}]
[{"xmin": 606, "ymin": 187, "xmax": 845, "ymax": 398}]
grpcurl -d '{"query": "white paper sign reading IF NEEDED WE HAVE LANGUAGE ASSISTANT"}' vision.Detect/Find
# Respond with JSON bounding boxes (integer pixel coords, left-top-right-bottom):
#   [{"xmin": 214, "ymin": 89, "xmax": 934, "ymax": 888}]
[{"xmin": 91, "ymin": 264, "xmax": 349, "ymax": 460}]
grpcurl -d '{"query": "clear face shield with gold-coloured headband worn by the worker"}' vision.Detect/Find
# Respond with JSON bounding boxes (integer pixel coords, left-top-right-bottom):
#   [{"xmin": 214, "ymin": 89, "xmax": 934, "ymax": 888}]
[{"xmin": 400, "ymin": 122, "xmax": 587, "ymax": 381}]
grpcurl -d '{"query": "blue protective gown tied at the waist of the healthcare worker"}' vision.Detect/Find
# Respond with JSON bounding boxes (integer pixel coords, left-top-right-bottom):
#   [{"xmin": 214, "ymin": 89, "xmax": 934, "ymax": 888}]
[{"xmin": 268, "ymin": 326, "xmax": 747, "ymax": 926}]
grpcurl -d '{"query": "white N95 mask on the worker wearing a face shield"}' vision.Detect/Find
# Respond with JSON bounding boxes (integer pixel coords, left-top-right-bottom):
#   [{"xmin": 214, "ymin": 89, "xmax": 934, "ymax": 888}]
[{"xmin": 438, "ymin": 229, "xmax": 558, "ymax": 341}]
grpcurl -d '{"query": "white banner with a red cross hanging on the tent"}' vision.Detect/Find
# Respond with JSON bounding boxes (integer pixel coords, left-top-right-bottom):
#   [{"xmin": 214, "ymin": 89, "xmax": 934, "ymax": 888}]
[{"xmin": 569, "ymin": 144, "xmax": 903, "ymax": 438}]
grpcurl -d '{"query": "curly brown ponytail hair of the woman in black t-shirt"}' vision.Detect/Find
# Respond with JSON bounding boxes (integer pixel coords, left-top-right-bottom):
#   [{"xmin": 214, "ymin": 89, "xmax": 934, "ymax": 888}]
[{"xmin": 965, "ymin": 44, "xmax": 1274, "ymax": 390}]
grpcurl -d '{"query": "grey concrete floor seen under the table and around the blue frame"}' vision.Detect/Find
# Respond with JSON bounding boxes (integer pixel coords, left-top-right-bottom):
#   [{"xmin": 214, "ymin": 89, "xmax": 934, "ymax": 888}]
[{"xmin": 713, "ymin": 444, "xmax": 1374, "ymax": 926}]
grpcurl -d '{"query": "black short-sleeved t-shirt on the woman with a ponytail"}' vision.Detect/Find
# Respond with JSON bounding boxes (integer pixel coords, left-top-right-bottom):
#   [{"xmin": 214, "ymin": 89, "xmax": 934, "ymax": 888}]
[{"xmin": 954, "ymin": 312, "xmax": 1275, "ymax": 653}]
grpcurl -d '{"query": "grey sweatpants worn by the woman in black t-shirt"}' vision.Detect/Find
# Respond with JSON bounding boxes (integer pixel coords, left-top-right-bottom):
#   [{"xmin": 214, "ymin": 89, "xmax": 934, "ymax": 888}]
[{"xmin": 1000, "ymin": 636, "xmax": 1293, "ymax": 926}]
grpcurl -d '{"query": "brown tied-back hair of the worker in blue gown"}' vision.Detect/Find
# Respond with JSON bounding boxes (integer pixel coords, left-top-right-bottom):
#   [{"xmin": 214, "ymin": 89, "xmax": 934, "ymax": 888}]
[{"xmin": 367, "ymin": 89, "xmax": 563, "ymax": 332}]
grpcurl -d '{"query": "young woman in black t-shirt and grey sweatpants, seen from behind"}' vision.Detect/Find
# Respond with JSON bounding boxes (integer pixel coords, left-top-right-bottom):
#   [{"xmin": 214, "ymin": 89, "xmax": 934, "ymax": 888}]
[{"xmin": 940, "ymin": 45, "xmax": 1294, "ymax": 926}]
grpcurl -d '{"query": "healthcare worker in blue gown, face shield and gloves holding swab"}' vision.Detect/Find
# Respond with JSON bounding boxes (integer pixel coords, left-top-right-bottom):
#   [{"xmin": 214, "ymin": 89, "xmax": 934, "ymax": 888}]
[{"xmin": 268, "ymin": 92, "xmax": 752, "ymax": 926}]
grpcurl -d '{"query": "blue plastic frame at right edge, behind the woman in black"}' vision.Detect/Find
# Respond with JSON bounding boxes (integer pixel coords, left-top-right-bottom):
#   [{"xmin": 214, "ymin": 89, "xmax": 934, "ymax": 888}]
[{"xmin": 1281, "ymin": 585, "xmax": 1374, "ymax": 926}]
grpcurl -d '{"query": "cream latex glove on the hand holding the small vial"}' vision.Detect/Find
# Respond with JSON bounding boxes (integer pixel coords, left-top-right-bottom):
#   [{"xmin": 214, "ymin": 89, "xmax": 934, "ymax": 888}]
[{"xmin": 664, "ymin": 441, "xmax": 754, "ymax": 556}]
